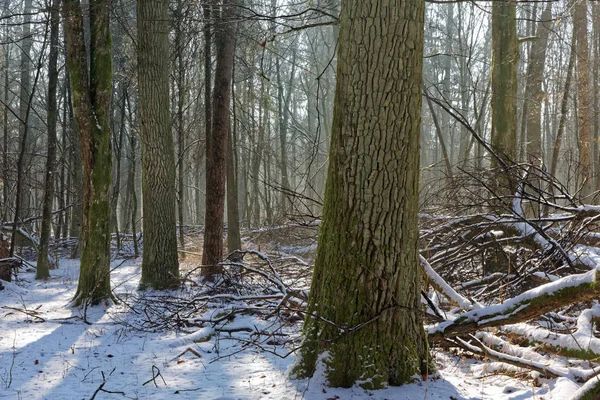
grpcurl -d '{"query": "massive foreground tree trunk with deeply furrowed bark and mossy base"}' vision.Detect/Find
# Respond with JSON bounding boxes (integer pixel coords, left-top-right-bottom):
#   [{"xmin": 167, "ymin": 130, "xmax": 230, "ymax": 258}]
[{"xmin": 296, "ymin": 0, "xmax": 428, "ymax": 389}]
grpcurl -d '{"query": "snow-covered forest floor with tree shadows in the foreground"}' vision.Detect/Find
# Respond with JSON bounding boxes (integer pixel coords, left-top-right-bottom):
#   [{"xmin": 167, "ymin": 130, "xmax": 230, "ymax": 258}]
[{"xmin": 0, "ymin": 260, "xmax": 577, "ymax": 400}]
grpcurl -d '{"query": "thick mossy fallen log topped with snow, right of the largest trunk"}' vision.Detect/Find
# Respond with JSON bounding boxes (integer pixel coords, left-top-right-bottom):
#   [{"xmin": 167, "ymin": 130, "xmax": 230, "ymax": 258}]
[{"xmin": 428, "ymin": 270, "xmax": 600, "ymax": 342}]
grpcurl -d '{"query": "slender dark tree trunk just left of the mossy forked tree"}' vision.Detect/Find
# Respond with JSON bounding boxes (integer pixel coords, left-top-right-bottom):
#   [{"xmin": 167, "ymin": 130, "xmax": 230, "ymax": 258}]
[{"xmin": 35, "ymin": 0, "xmax": 60, "ymax": 279}]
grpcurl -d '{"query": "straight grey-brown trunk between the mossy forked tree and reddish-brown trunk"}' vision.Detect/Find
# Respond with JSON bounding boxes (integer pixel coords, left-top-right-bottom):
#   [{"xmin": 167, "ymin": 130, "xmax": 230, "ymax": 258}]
[{"xmin": 137, "ymin": 0, "xmax": 179, "ymax": 289}]
